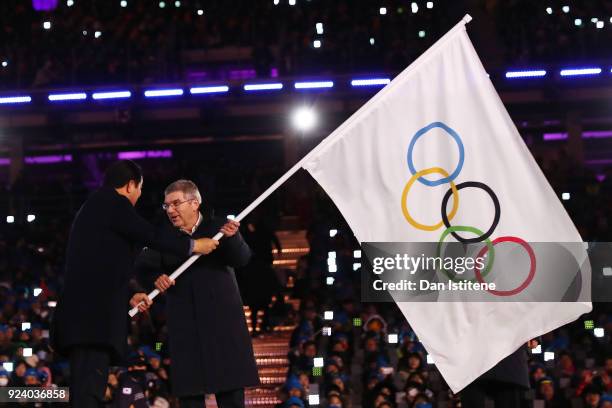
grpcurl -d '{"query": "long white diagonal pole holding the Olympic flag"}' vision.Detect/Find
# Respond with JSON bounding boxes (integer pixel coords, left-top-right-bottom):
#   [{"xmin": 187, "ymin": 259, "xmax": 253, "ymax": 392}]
[{"xmin": 129, "ymin": 14, "xmax": 472, "ymax": 317}]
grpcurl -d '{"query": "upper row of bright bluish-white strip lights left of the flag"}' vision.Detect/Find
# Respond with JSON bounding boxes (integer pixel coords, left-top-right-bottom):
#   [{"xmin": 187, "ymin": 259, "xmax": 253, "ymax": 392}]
[{"xmin": 0, "ymin": 78, "xmax": 391, "ymax": 104}]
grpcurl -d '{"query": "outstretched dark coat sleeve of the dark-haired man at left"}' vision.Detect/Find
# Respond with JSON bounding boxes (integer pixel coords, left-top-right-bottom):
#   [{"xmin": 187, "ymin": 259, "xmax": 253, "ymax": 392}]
[{"xmin": 110, "ymin": 199, "xmax": 191, "ymax": 256}]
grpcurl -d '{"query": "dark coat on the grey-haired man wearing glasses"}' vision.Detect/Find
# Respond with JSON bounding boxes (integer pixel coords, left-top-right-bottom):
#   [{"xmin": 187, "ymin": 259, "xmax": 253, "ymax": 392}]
[{"xmin": 137, "ymin": 217, "xmax": 259, "ymax": 397}]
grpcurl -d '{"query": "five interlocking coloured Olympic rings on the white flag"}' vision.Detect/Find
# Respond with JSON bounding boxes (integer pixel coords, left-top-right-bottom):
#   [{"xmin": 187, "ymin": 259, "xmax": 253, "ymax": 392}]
[{"xmin": 401, "ymin": 122, "xmax": 536, "ymax": 296}]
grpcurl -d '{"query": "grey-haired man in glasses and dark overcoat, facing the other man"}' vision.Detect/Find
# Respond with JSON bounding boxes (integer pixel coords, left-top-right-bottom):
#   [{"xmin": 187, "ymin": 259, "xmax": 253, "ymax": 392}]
[{"xmin": 137, "ymin": 180, "xmax": 259, "ymax": 408}]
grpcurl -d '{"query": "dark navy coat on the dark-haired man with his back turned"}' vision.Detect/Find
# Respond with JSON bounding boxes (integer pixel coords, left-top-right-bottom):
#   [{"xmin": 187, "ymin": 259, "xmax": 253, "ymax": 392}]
[{"xmin": 51, "ymin": 187, "xmax": 191, "ymax": 362}]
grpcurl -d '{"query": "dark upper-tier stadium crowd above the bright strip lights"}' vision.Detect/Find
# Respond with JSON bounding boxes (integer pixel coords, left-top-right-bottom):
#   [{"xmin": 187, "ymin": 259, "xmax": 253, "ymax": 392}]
[{"xmin": 0, "ymin": 0, "xmax": 612, "ymax": 89}]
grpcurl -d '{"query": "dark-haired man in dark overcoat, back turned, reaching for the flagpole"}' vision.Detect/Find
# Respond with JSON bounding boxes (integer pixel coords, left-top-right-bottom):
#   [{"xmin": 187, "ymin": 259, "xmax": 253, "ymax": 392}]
[{"xmin": 51, "ymin": 160, "xmax": 218, "ymax": 408}]
